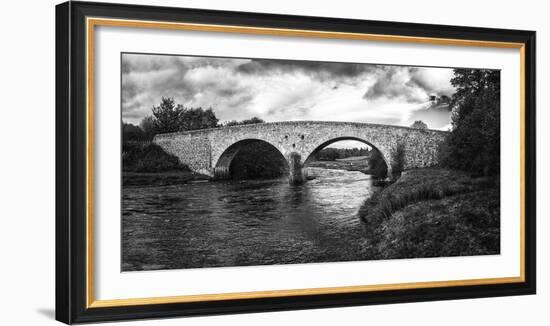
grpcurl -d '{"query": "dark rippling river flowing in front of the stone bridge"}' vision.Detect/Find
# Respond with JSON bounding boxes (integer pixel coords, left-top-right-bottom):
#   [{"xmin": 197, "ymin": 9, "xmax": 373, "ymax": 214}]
[{"xmin": 122, "ymin": 168, "xmax": 378, "ymax": 271}]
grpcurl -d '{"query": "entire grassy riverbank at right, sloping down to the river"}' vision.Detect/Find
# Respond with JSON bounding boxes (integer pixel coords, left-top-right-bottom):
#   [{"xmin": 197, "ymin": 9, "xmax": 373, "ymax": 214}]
[{"xmin": 359, "ymin": 169, "xmax": 500, "ymax": 259}]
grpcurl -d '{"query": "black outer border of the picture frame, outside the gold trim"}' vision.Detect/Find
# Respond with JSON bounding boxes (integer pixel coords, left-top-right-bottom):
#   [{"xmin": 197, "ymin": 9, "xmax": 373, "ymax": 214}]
[{"xmin": 56, "ymin": 1, "xmax": 536, "ymax": 324}]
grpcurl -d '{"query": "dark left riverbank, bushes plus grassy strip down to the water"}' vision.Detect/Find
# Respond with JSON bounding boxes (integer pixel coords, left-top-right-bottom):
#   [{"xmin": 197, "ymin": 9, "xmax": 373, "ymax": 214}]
[{"xmin": 122, "ymin": 142, "xmax": 210, "ymax": 186}]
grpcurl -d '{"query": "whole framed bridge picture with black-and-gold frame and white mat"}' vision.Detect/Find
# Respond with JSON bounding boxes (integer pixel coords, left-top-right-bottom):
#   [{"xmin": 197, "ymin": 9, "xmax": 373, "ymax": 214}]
[{"xmin": 56, "ymin": 1, "xmax": 535, "ymax": 324}]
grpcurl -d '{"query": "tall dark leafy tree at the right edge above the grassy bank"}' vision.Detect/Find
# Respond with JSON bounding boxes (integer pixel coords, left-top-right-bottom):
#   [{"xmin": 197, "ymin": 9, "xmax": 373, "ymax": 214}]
[{"xmin": 439, "ymin": 69, "xmax": 500, "ymax": 175}]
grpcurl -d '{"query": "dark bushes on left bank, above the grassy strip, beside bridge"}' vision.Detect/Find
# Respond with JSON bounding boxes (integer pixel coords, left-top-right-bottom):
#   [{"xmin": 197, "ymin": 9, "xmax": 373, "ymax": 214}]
[{"xmin": 122, "ymin": 142, "xmax": 189, "ymax": 172}]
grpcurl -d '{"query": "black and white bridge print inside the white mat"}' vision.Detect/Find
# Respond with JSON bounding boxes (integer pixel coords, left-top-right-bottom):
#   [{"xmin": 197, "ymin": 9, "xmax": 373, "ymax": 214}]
[{"xmin": 121, "ymin": 53, "xmax": 500, "ymax": 272}]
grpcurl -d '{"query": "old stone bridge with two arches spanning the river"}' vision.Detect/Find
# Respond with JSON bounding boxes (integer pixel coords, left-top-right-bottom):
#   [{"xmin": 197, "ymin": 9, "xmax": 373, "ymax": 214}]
[{"xmin": 153, "ymin": 121, "xmax": 447, "ymax": 183}]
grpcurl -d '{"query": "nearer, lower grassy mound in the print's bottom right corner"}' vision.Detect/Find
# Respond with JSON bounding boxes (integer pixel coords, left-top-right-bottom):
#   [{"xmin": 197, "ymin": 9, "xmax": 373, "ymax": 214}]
[{"xmin": 375, "ymin": 190, "xmax": 500, "ymax": 259}]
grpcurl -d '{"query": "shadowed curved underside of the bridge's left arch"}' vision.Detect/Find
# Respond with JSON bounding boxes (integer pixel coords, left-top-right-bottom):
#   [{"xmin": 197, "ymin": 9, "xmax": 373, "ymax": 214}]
[{"xmin": 214, "ymin": 138, "xmax": 288, "ymax": 179}]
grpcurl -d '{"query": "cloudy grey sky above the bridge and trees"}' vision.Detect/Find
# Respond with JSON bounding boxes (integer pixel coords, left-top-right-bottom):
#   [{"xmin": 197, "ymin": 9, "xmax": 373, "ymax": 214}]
[{"xmin": 122, "ymin": 54, "xmax": 460, "ymax": 129}]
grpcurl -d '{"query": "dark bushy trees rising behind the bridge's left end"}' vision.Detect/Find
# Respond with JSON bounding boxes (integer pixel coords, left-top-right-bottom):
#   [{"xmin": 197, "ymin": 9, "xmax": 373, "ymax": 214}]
[{"xmin": 122, "ymin": 97, "xmax": 264, "ymax": 142}]
